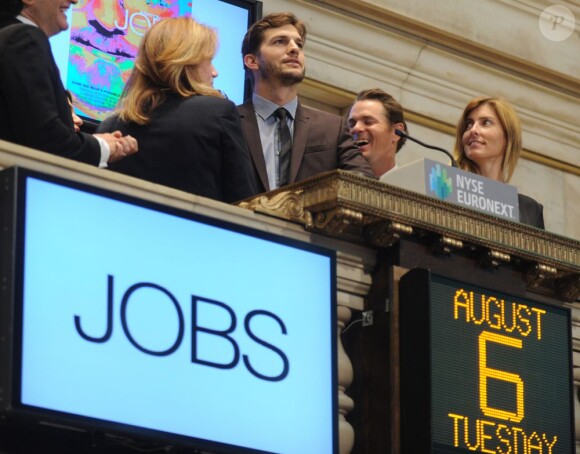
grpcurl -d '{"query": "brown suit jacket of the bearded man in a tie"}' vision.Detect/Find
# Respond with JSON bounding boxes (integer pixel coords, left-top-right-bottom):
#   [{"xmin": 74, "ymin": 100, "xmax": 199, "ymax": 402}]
[{"xmin": 238, "ymin": 100, "xmax": 376, "ymax": 192}]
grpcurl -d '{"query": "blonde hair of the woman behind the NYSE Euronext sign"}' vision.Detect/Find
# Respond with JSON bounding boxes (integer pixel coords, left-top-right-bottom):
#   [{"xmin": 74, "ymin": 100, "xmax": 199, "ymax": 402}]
[{"xmin": 453, "ymin": 96, "xmax": 522, "ymax": 183}]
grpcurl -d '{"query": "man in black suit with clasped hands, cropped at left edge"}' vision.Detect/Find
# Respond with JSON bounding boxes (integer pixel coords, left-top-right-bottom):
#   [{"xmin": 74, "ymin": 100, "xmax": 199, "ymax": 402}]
[{"xmin": 0, "ymin": 0, "xmax": 137, "ymax": 167}]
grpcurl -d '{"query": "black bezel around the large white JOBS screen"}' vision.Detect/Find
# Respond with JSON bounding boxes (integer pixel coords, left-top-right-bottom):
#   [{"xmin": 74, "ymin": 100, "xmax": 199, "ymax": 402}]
[{"xmin": 0, "ymin": 167, "xmax": 339, "ymax": 454}]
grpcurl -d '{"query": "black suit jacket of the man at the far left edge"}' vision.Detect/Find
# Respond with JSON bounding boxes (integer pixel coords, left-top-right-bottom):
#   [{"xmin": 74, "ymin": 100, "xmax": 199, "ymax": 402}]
[{"xmin": 0, "ymin": 19, "xmax": 101, "ymax": 165}]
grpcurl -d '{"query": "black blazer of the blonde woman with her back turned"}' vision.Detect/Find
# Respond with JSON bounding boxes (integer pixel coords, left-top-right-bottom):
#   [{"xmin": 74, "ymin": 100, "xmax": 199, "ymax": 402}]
[{"xmin": 97, "ymin": 94, "xmax": 257, "ymax": 202}]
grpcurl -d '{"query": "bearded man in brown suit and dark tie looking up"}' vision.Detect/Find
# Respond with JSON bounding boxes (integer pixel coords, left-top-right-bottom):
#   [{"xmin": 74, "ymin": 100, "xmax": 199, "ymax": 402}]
[{"xmin": 238, "ymin": 13, "xmax": 373, "ymax": 192}]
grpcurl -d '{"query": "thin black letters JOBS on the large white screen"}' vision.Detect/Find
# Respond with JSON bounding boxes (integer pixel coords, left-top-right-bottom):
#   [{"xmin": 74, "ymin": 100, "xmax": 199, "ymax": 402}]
[{"xmin": 74, "ymin": 275, "xmax": 290, "ymax": 382}]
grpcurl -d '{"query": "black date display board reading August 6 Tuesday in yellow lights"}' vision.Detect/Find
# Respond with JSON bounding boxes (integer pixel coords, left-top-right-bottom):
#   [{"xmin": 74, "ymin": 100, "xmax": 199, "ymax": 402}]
[{"xmin": 399, "ymin": 268, "xmax": 576, "ymax": 454}]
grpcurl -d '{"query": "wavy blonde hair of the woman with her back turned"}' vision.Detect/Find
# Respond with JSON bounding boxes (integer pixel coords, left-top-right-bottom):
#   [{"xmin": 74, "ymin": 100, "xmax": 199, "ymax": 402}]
[{"xmin": 119, "ymin": 17, "xmax": 223, "ymax": 125}]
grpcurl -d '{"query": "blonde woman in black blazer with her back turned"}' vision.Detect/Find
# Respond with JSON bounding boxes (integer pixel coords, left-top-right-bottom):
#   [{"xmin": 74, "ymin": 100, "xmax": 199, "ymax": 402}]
[{"xmin": 98, "ymin": 17, "xmax": 256, "ymax": 202}]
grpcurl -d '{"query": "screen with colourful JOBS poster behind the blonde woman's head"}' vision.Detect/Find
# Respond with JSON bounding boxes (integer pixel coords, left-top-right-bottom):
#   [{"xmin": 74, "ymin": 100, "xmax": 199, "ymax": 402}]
[{"xmin": 50, "ymin": 0, "xmax": 261, "ymax": 123}]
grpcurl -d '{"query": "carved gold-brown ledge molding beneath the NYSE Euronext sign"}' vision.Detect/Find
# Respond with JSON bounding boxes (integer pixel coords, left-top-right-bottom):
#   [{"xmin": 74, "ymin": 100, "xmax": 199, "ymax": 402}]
[{"xmin": 242, "ymin": 170, "xmax": 580, "ymax": 301}]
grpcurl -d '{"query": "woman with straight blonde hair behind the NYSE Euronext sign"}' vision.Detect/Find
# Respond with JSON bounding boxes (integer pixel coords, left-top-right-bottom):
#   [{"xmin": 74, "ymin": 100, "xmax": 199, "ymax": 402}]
[{"xmin": 454, "ymin": 96, "xmax": 544, "ymax": 229}]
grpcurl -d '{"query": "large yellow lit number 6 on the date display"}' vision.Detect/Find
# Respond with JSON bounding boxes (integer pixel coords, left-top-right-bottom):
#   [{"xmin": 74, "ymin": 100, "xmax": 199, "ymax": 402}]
[{"xmin": 479, "ymin": 331, "xmax": 524, "ymax": 422}]
